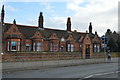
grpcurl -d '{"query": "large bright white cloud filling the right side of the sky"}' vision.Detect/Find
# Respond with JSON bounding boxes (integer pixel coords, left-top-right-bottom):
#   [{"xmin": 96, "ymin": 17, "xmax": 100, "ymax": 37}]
[{"xmin": 66, "ymin": 0, "xmax": 118, "ymax": 35}]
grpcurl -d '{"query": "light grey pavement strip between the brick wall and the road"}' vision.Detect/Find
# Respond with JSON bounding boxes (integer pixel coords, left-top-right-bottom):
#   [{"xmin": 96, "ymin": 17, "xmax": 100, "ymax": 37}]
[{"xmin": 2, "ymin": 58, "xmax": 118, "ymax": 72}]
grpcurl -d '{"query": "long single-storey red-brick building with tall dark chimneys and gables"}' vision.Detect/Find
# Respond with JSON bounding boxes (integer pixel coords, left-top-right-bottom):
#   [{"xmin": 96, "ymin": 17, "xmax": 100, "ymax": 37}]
[{"xmin": 1, "ymin": 6, "xmax": 101, "ymax": 57}]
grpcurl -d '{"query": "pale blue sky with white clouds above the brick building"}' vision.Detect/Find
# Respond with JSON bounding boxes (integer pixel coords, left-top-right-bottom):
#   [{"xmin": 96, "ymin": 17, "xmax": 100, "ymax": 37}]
[{"xmin": 0, "ymin": 0, "xmax": 118, "ymax": 36}]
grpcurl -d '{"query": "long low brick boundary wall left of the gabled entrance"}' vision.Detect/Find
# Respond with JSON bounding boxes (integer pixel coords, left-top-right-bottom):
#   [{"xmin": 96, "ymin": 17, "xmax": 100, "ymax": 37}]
[{"xmin": 2, "ymin": 52, "xmax": 82, "ymax": 61}]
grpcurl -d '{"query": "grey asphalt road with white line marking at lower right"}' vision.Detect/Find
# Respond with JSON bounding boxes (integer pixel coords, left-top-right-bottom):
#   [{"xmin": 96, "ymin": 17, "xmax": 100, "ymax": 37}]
[{"xmin": 3, "ymin": 62, "xmax": 118, "ymax": 80}]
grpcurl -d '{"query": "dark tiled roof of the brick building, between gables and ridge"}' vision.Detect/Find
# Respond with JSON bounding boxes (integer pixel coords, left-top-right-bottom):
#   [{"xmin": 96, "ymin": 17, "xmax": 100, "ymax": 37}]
[{"xmin": 4, "ymin": 23, "xmax": 94, "ymax": 41}]
